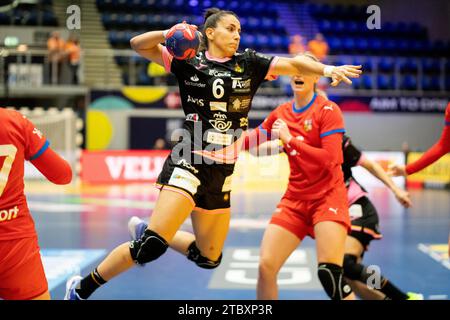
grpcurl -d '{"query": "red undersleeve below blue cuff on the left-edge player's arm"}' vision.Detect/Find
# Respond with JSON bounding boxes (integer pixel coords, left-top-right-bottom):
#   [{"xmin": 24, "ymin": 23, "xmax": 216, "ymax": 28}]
[{"xmin": 30, "ymin": 148, "xmax": 72, "ymax": 184}]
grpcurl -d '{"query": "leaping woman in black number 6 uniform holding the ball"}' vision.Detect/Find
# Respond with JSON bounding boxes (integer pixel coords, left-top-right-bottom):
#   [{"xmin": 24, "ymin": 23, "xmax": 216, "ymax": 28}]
[{"xmin": 65, "ymin": 8, "xmax": 361, "ymax": 300}]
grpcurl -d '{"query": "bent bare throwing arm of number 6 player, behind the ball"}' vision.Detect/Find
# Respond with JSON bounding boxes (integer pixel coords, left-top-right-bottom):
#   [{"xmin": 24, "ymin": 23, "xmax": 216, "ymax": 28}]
[{"xmin": 130, "ymin": 30, "xmax": 165, "ymax": 66}]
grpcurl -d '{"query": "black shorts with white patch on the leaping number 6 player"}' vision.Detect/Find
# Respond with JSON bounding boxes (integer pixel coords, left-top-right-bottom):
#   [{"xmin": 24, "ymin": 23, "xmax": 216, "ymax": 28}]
[{"xmin": 156, "ymin": 154, "xmax": 234, "ymax": 213}]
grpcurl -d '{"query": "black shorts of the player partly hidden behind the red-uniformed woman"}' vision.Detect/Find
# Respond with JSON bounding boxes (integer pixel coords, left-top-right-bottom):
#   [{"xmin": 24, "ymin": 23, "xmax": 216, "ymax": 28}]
[{"xmin": 349, "ymin": 197, "xmax": 383, "ymax": 250}]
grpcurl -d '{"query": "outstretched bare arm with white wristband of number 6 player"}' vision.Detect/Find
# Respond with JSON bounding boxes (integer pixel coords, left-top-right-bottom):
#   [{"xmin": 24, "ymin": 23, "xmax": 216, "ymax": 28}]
[{"xmin": 271, "ymin": 56, "xmax": 362, "ymax": 86}]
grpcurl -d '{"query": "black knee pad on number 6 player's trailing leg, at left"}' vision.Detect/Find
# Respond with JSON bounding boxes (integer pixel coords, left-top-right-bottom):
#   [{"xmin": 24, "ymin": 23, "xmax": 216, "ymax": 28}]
[{"xmin": 130, "ymin": 229, "xmax": 169, "ymax": 264}]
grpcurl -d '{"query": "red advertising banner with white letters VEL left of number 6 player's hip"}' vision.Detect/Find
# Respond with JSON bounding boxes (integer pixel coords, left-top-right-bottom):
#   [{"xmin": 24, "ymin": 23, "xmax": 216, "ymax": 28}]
[{"xmin": 80, "ymin": 150, "xmax": 170, "ymax": 183}]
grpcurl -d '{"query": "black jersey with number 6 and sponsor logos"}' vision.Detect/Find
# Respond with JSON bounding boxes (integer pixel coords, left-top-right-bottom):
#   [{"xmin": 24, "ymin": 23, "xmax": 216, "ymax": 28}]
[{"xmin": 170, "ymin": 49, "xmax": 273, "ymax": 163}]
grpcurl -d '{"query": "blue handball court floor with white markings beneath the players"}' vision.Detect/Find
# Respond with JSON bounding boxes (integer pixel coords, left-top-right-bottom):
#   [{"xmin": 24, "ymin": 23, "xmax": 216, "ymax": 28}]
[{"xmin": 26, "ymin": 181, "xmax": 450, "ymax": 300}]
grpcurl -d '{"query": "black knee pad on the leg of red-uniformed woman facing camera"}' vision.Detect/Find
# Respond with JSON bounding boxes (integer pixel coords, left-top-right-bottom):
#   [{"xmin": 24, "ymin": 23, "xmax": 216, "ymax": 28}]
[{"xmin": 317, "ymin": 263, "xmax": 352, "ymax": 300}]
